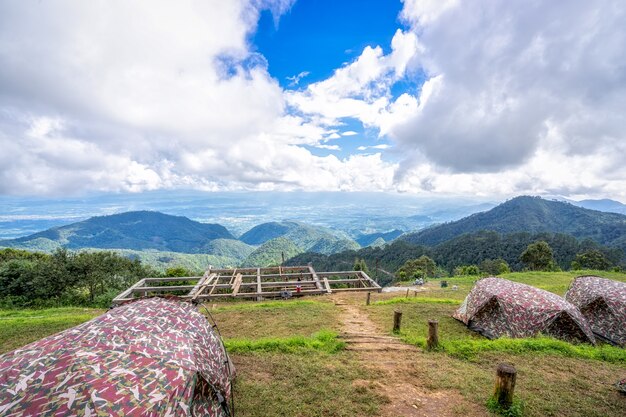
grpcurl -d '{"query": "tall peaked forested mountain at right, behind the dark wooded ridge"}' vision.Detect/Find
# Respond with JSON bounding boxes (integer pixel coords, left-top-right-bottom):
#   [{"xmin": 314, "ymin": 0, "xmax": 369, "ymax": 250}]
[{"xmin": 400, "ymin": 196, "xmax": 626, "ymax": 249}]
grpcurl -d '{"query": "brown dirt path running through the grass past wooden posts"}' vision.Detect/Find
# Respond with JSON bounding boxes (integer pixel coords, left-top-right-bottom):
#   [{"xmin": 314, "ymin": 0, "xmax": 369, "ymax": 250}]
[{"xmin": 334, "ymin": 298, "xmax": 484, "ymax": 417}]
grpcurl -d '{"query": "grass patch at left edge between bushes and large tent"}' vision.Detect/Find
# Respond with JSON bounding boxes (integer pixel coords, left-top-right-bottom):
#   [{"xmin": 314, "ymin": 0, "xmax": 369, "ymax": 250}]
[{"xmin": 0, "ymin": 307, "xmax": 104, "ymax": 353}]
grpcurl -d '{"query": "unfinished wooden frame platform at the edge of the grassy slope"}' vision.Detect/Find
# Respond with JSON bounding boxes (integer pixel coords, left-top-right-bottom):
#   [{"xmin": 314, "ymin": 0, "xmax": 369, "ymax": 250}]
[{"xmin": 113, "ymin": 265, "xmax": 382, "ymax": 305}]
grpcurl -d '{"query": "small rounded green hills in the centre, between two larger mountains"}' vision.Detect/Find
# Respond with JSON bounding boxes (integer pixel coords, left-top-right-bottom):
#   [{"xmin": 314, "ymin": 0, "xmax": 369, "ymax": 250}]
[{"xmin": 239, "ymin": 221, "xmax": 360, "ymax": 254}]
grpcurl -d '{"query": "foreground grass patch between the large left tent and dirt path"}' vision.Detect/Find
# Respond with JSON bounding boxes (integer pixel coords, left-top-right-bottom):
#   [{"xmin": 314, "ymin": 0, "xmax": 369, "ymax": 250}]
[{"xmin": 232, "ymin": 351, "xmax": 388, "ymax": 417}]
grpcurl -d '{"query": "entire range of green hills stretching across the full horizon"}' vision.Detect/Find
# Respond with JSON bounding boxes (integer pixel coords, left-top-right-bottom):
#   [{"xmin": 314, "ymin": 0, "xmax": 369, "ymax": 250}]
[{"xmin": 0, "ymin": 196, "xmax": 626, "ymax": 269}]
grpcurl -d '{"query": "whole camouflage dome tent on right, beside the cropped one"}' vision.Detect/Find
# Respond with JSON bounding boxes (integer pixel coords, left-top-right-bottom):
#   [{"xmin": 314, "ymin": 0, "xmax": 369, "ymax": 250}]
[{"xmin": 453, "ymin": 277, "xmax": 595, "ymax": 343}]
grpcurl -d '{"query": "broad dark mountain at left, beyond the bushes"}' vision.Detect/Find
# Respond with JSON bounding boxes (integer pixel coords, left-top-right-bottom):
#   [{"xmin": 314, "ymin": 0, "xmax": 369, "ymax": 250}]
[{"xmin": 0, "ymin": 211, "xmax": 235, "ymax": 253}]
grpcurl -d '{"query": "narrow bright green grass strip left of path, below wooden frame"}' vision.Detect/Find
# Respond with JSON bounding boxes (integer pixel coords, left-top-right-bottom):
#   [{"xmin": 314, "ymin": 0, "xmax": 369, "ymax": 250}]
[{"xmin": 224, "ymin": 330, "xmax": 345, "ymax": 353}]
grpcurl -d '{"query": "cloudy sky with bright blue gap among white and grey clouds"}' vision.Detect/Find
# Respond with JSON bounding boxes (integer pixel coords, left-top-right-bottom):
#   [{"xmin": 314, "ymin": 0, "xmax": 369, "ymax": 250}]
[{"xmin": 0, "ymin": 0, "xmax": 626, "ymax": 201}]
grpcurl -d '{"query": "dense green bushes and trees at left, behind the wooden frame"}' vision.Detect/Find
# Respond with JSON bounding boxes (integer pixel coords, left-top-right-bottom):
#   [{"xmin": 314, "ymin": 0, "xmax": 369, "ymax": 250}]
[{"xmin": 0, "ymin": 249, "xmax": 195, "ymax": 308}]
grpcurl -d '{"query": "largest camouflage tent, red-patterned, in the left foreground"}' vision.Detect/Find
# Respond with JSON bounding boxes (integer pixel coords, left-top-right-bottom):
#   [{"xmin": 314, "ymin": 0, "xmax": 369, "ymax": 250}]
[{"xmin": 0, "ymin": 298, "xmax": 232, "ymax": 417}]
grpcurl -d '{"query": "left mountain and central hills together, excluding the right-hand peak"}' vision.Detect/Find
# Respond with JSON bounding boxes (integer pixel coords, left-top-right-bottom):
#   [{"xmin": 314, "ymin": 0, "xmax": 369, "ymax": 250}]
[{"xmin": 0, "ymin": 211, "xmax": 361, "ymax": 266}]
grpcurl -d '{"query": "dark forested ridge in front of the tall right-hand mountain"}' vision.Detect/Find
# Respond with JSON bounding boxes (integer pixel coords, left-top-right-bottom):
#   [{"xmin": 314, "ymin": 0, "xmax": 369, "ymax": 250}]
[{"xmin": 287, "ymin": 231, "xmax": 624, "ymax": 285}]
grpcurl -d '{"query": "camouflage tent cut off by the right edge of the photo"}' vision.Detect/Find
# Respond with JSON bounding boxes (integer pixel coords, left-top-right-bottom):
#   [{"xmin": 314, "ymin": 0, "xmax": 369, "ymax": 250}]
[{"xmin": 565, "ymin": 276, "xmax": 626, "ymax": 346}]
